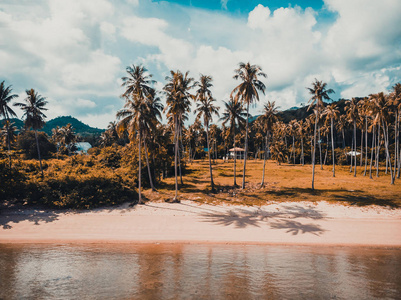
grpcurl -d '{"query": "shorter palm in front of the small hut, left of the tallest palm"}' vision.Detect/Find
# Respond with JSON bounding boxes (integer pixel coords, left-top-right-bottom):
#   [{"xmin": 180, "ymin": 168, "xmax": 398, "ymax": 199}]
[{"xmin": 220, "ymin": 98, "xmax": 247, "ymax": 187}]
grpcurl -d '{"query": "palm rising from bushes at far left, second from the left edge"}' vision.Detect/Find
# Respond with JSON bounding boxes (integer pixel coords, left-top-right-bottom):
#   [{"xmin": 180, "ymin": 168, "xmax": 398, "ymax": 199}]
[{"xmin": 14, "ymin": 89, "xmax": 47, "ymax": 177}]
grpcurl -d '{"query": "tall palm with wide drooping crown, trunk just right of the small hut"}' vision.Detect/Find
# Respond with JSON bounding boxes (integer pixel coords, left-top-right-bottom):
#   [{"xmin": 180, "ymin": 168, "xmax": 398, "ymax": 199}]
[{"xmin": 231, "ymin": 62, "xmax": 267, "ymax": 189}]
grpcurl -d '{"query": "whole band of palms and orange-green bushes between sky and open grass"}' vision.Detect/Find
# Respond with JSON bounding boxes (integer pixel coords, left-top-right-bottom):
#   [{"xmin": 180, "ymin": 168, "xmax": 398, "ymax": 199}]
[{"xmin": 0, "ymin": 63, "xmax": 401, "ymax": 208}]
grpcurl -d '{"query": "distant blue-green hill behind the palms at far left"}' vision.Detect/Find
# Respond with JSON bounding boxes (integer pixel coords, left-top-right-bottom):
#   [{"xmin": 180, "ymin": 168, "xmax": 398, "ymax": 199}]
[{"xmin": 0, "ymin": 116, "xmax": 105, "ymax": 137}]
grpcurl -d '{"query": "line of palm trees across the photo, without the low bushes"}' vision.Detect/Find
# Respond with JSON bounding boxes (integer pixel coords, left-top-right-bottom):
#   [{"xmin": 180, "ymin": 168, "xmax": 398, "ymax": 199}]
[{"xmin": 0, "ymin": 63, "xmax": 401, "ymax": 203}]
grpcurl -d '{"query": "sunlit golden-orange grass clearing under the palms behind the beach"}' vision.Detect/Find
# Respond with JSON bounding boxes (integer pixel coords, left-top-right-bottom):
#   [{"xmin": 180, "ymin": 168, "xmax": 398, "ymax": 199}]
[{"xmin": 144, "ymin": 159, "xmax": 401, "ymax": 208}]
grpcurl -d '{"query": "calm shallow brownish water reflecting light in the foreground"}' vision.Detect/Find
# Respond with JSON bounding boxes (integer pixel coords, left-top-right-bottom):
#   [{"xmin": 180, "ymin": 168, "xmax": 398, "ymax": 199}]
[{"xmin": 0, "ymin": 244, "xmax": 401, "ymax": 299}]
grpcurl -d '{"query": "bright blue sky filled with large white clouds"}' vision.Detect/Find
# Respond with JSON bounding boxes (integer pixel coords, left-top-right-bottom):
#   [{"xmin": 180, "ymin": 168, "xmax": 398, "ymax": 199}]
[{"xmin": 0, "ymin": 0, "xmax": 401, "ymax": 128}]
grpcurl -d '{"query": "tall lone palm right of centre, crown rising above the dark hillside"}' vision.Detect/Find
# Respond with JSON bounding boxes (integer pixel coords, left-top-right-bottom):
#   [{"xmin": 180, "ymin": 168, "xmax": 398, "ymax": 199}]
[{"xmin": 307, "ymin": 79, "xmax": 334, "ymax": 190}]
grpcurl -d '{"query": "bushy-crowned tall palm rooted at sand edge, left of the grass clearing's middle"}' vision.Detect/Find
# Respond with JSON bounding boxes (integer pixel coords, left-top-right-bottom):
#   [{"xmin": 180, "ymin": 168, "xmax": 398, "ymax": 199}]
[{"xmin": 163, "ymin": 71, "xmax": 194, "ymax": 201}]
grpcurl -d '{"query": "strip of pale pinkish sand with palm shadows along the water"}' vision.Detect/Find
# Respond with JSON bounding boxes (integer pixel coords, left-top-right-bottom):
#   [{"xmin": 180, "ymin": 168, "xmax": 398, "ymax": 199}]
[{"xmin": 0, "ymin": 201, "xmax": 401, "ymax": 247}]
